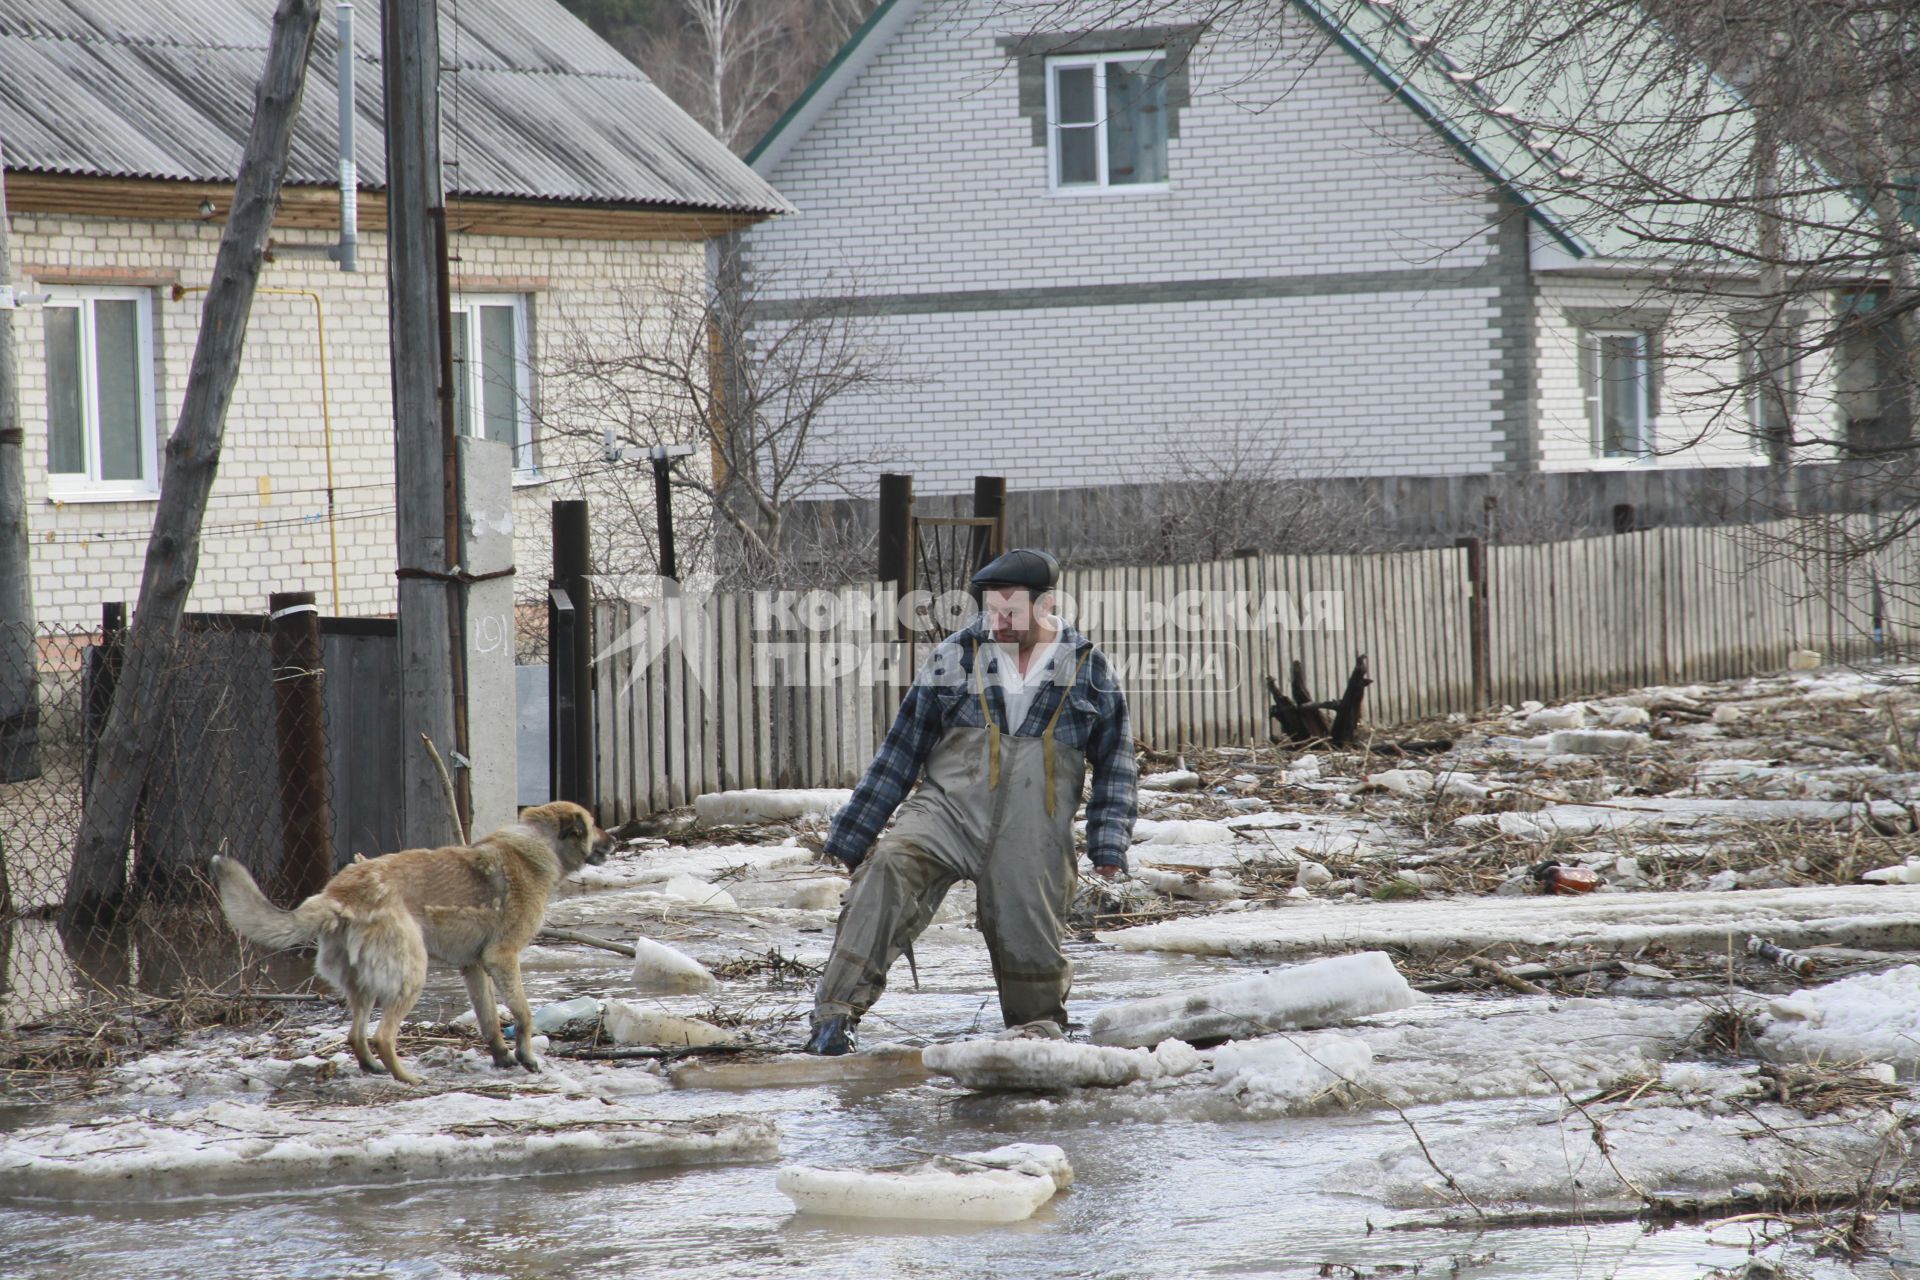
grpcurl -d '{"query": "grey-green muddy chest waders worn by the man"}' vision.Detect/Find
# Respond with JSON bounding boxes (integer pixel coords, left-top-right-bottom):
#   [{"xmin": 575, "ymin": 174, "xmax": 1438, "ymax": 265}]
[{"xmin": 814, "ymin": 651, "xmax": 1091, "ymax": 1027}]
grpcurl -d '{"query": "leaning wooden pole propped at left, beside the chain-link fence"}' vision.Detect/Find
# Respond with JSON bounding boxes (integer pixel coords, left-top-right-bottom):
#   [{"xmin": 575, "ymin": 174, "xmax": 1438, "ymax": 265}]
[{"xmin": 60, "ymin": 0, "xmax": 322, "ymax": 929}]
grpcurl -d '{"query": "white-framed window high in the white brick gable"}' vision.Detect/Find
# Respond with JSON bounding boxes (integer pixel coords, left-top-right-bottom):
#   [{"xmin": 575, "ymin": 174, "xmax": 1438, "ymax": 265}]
[{"xmin": 1046, "ymin": 52, "xmax": 1167, "ymax": 190}]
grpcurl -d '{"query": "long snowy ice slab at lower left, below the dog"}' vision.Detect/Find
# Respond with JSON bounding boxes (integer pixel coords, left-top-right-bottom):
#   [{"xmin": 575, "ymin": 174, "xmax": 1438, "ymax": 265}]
[{"xmin": 0, "ymin": 1092, "xmax": 780, "ymax": 1201}]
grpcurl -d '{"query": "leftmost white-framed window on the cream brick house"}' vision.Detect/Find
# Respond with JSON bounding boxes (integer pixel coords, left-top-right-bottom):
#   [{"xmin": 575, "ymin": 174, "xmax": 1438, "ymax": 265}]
[{"xmin": 40, "ymin": 288, "xmax": 159, "ymax": 501}]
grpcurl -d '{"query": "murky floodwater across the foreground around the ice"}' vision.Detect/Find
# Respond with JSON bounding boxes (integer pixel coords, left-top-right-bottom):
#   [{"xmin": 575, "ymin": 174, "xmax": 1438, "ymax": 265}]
[{"xmin": 0, "ymin": 936, "xmax": 1920, "ymax": 1280}]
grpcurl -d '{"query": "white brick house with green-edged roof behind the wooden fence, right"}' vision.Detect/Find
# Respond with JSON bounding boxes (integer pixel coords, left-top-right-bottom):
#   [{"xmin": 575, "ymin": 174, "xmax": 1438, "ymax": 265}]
[{"xmin": 743, "ymin": 0, "xmax": 1866, "ymax": 493}]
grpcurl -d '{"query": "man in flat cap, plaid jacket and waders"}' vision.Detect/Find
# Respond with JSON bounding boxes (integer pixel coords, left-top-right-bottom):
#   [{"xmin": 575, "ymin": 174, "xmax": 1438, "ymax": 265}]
[{"xmin": 806, "ymin": 551, "xmax": 1135, "ymax": 1054}]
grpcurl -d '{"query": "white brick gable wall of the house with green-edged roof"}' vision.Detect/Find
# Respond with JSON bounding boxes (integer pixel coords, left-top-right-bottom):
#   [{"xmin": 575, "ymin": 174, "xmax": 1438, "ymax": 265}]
[{"xmin": 749, "ymin": 0, "xmax": 1524, "ymax": 493}]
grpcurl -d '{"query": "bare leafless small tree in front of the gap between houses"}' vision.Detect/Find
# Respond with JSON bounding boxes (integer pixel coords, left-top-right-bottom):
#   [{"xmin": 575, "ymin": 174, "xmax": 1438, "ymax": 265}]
[{"xmin": 540, "ymin": 248, "xmax": 906, "ymax": 587}]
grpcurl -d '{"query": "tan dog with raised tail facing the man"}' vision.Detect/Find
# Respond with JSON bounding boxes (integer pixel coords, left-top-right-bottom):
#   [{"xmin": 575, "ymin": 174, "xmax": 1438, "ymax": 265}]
[{"xmin": 211, "ymin": 800, "xmax": 612, "ymax": 1084}]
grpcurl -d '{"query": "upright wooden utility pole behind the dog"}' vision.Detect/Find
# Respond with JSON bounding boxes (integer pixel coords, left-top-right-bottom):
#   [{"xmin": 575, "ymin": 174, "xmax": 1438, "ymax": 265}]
[{"xmin": 380, "ymin": 0, "xmax": 470, "ymax": 848}]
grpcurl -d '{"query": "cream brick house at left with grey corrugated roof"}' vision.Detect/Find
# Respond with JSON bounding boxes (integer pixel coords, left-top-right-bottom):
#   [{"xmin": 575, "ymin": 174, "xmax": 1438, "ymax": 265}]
[{"xmin": 0, "ymin": 0, "xmax": 787, "ymax": 626}]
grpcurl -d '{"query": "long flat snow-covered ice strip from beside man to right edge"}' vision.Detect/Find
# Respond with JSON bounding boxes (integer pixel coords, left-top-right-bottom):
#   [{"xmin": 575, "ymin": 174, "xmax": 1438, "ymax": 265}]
[{"xmin": 1094, "ymin": 885, "xmax": 1920, "ymax": 958}]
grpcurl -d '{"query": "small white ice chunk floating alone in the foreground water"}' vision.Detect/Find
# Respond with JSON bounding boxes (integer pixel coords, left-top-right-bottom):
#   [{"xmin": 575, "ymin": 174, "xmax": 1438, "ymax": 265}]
[{"xmin": 774, "ymin": 1144, "xmax": 1073, "ymax": 1222}]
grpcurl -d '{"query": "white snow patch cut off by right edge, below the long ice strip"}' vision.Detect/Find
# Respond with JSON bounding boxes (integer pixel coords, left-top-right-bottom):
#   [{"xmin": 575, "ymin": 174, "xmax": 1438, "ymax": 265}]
[{"xmin": 1761, "ymin": 965, "xmax": 1920, "ymax": 1079}]
